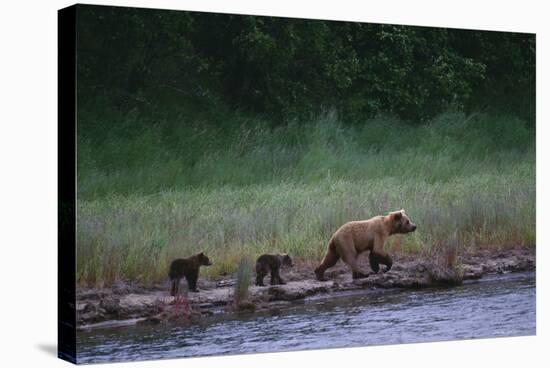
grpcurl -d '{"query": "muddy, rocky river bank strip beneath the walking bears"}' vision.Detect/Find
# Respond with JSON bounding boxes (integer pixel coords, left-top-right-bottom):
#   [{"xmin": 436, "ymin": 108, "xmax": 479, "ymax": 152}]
[{"xmin": 77, "ymin": 248, "xmax": 535, "ymax": 329}]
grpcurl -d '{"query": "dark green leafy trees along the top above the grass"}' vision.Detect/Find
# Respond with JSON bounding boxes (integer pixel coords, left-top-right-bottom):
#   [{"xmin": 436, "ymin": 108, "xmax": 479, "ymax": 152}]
[{"xmin": 78, "ymin": 6, "xmax": 535, "ymax": 122}]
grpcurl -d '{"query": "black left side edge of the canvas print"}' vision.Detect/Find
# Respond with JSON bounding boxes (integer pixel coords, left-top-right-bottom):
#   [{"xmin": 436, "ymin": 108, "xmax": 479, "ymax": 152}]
[{"xmin": 57, "ymin": 5, "xmax": 77, "ymax": 363}]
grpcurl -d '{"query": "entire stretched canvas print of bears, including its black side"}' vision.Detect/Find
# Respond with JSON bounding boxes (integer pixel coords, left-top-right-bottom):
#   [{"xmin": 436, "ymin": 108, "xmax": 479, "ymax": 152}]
[{"xmin": 58, "ymin": 5, "xmax": 536, "ymax": 363}]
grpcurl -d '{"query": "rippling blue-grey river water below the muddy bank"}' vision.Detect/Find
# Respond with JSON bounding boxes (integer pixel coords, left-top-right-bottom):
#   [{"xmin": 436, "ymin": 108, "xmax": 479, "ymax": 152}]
[{"xmin": 77, "ymin": 272, "xmax": 536, "ymax": 363}]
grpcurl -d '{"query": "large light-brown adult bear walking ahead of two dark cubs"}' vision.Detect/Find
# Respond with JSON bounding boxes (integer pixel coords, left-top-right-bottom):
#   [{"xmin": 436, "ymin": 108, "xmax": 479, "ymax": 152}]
[{"xmin": 315, "ymin": 210, "xmax": 416, "ymax": 281}]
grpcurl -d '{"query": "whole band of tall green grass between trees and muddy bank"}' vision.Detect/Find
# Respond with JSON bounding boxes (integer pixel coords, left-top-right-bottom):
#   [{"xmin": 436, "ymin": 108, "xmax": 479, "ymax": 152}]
[{"xmin": 77, "ymin": 113, "xmax": 535, "ymax": 285}]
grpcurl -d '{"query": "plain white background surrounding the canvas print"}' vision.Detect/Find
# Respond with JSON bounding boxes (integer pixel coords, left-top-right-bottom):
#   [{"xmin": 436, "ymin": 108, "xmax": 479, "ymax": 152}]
[{"xmin": 0, "ymin": 0, "xmax": 550, "ymax": 368}]
